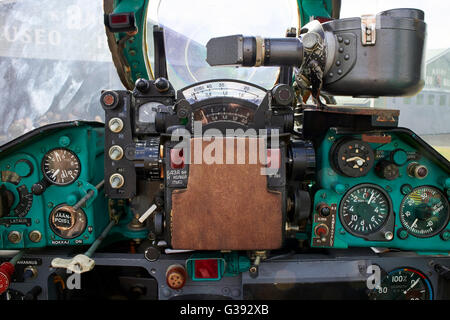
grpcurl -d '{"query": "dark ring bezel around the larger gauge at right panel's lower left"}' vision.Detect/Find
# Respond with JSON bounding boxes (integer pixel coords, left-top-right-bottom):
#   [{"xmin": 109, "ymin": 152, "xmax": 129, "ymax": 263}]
[{"xmin": 339, "ymin": 183, "xmax": 393, "ymax": 238}]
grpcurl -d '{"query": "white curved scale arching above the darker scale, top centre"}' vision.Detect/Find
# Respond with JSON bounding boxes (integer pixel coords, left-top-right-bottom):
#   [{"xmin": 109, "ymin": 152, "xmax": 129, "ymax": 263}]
[{"xmin": 182, "ymin": 81, "xmax": 266, "ymax": 105}]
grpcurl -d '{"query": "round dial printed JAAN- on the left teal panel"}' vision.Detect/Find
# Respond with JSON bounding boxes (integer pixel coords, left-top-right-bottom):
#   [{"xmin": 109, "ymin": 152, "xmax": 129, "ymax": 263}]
[{"xmin": 50, "ymin": 204, "xmax": 87, "ymax": 239}]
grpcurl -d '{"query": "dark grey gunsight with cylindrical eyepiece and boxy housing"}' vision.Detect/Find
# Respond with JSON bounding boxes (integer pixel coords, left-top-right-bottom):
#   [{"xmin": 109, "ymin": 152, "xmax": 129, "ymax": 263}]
[{"xmin": 206, "ymin": 9, "xmax": 426, "ymax": 96}]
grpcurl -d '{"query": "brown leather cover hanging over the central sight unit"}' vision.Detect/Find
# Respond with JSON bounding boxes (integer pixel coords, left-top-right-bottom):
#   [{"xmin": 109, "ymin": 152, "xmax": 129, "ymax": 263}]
[{"xmin": 170, "ymin": 138, "xmax": 282, "ymax": 250}]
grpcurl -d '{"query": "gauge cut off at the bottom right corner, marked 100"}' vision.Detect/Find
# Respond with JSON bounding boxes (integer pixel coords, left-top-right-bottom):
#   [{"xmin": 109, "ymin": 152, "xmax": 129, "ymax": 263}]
[{"xmin": 369, "ymin": 268, "xmax": 433, "ymax": 300}]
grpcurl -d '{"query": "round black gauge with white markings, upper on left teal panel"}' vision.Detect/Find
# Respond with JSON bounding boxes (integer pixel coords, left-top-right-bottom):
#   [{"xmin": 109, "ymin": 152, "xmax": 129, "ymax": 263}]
[{"xmin": 42, "ymin": 148, "xmax": 81, "ymax": 186}]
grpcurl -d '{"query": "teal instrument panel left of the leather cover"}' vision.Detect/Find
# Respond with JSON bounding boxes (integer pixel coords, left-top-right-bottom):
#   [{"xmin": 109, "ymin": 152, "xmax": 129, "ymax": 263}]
[{"xmin": 0, "ymin": 122, "xmax": 109, "ymax": 249}]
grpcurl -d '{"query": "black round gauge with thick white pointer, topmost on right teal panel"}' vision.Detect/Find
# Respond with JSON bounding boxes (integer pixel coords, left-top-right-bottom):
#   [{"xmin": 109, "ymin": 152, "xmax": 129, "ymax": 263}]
[{"xmin": 330, "ymin": 139, "xmax": 375, "ymax": 178}]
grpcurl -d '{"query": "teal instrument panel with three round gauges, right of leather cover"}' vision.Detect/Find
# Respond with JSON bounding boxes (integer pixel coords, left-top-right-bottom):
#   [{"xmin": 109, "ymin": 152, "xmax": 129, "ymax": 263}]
[{"xmin": 311, "ymin": 128, "xmax": 450, "ymax": 253}]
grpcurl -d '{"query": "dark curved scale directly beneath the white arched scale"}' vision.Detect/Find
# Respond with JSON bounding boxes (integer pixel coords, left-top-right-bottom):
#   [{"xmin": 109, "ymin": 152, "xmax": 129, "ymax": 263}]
[{"xmin": 194, "ymin": 103, "xmax": 255, "ymax": 125}]
